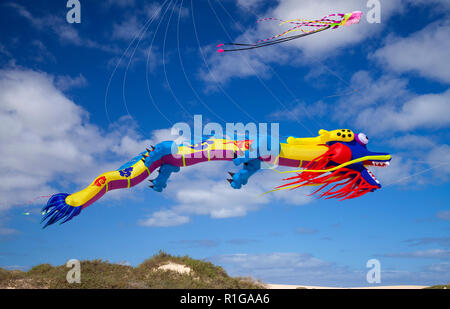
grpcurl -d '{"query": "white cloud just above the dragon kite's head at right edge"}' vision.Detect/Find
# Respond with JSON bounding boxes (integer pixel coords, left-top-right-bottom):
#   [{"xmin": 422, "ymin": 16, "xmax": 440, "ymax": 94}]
[{"xmin": 331, "ymin": 71, "xmax": 450, "ymax": 135}]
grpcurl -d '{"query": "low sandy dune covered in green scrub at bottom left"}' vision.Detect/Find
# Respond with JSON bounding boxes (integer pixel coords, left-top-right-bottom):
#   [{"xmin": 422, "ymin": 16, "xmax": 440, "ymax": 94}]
[{"xmin": 0, "ymin": 251, "xmax": 264, "ymax": 289}]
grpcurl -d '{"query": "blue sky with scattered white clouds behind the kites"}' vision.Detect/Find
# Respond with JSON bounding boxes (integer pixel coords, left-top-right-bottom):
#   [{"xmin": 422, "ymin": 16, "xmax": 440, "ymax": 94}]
[{"xmin": 0, "ymin": 0, "xmax": 450, "ymax": 286}]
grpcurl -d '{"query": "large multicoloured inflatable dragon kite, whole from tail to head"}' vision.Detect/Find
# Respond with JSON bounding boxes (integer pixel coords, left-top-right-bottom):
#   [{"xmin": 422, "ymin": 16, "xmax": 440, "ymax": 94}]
[{"xmin": 42, "ymin": 129, "xmax": 391, "ymax": 228}]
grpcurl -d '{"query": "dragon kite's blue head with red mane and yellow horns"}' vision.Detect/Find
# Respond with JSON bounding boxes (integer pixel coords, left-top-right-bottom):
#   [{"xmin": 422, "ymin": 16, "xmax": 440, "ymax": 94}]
[{"xmin": 277, "ymin": 129, "xmax": 391, "ymax": 200}]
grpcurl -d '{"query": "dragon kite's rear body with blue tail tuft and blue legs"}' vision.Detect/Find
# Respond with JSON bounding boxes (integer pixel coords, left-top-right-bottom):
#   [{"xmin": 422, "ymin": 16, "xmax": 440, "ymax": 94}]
[{"xmin": 41, "ymin": 137, "xmax": 261, "ymax": 228}]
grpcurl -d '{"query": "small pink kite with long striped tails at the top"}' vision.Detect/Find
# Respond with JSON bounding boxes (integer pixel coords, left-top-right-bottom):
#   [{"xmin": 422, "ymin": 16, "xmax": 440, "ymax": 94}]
[{"xmin": 217, "ymin": 11, "xmax": 363, "ymax": 53}]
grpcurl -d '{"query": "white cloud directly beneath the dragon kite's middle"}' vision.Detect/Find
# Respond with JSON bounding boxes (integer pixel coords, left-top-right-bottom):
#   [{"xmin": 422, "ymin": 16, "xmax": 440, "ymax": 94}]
[{"xmin": 141, "ymin": 162, "xmax": 313, "ymax": 226}]
